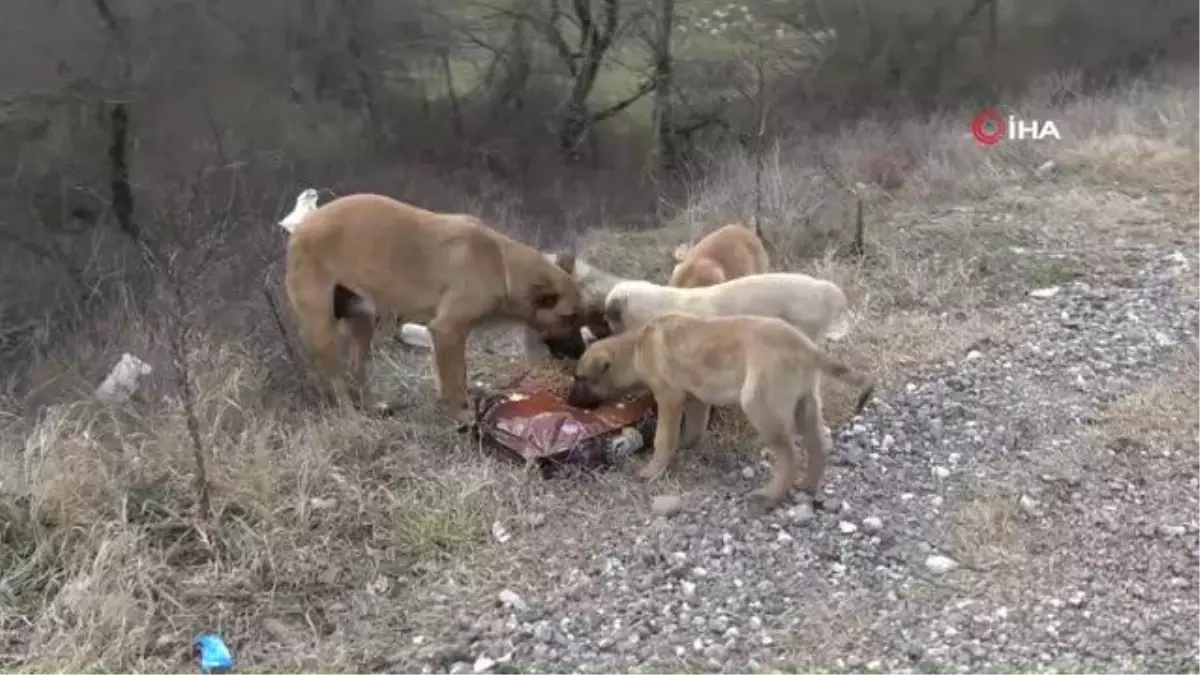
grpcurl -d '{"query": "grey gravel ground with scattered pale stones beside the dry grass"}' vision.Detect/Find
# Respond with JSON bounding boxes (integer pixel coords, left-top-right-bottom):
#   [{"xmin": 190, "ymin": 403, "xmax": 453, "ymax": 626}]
[{"xmin": 379, "ymin": 243, "xmax": 1200, "ymax": 673}]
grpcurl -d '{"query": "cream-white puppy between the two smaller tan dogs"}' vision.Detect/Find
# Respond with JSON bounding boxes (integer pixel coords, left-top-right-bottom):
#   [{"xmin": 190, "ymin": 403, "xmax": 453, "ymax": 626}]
[{"xmin": 605, "ymin": 271, "xmax": 850, "ymax": 341}]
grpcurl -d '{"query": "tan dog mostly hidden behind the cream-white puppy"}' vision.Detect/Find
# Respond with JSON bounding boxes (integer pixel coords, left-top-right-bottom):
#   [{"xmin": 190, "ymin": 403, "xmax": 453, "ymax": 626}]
[{"xmin": 667, "ymin": 223, "xmax": 769, "ymax": 288}]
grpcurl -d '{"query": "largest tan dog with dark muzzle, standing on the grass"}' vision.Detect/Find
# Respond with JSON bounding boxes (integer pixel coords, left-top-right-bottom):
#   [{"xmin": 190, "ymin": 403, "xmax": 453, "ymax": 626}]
[{"xmin": 287, "ymin": 195, "xmax": 582, "ymax": 424}]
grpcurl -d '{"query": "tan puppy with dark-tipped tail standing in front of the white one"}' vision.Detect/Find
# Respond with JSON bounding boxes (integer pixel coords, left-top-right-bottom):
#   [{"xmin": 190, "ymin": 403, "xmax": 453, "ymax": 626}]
[{"xmin": 570, "ymin": 312, "xmax": 872, "ymax": 508}]
